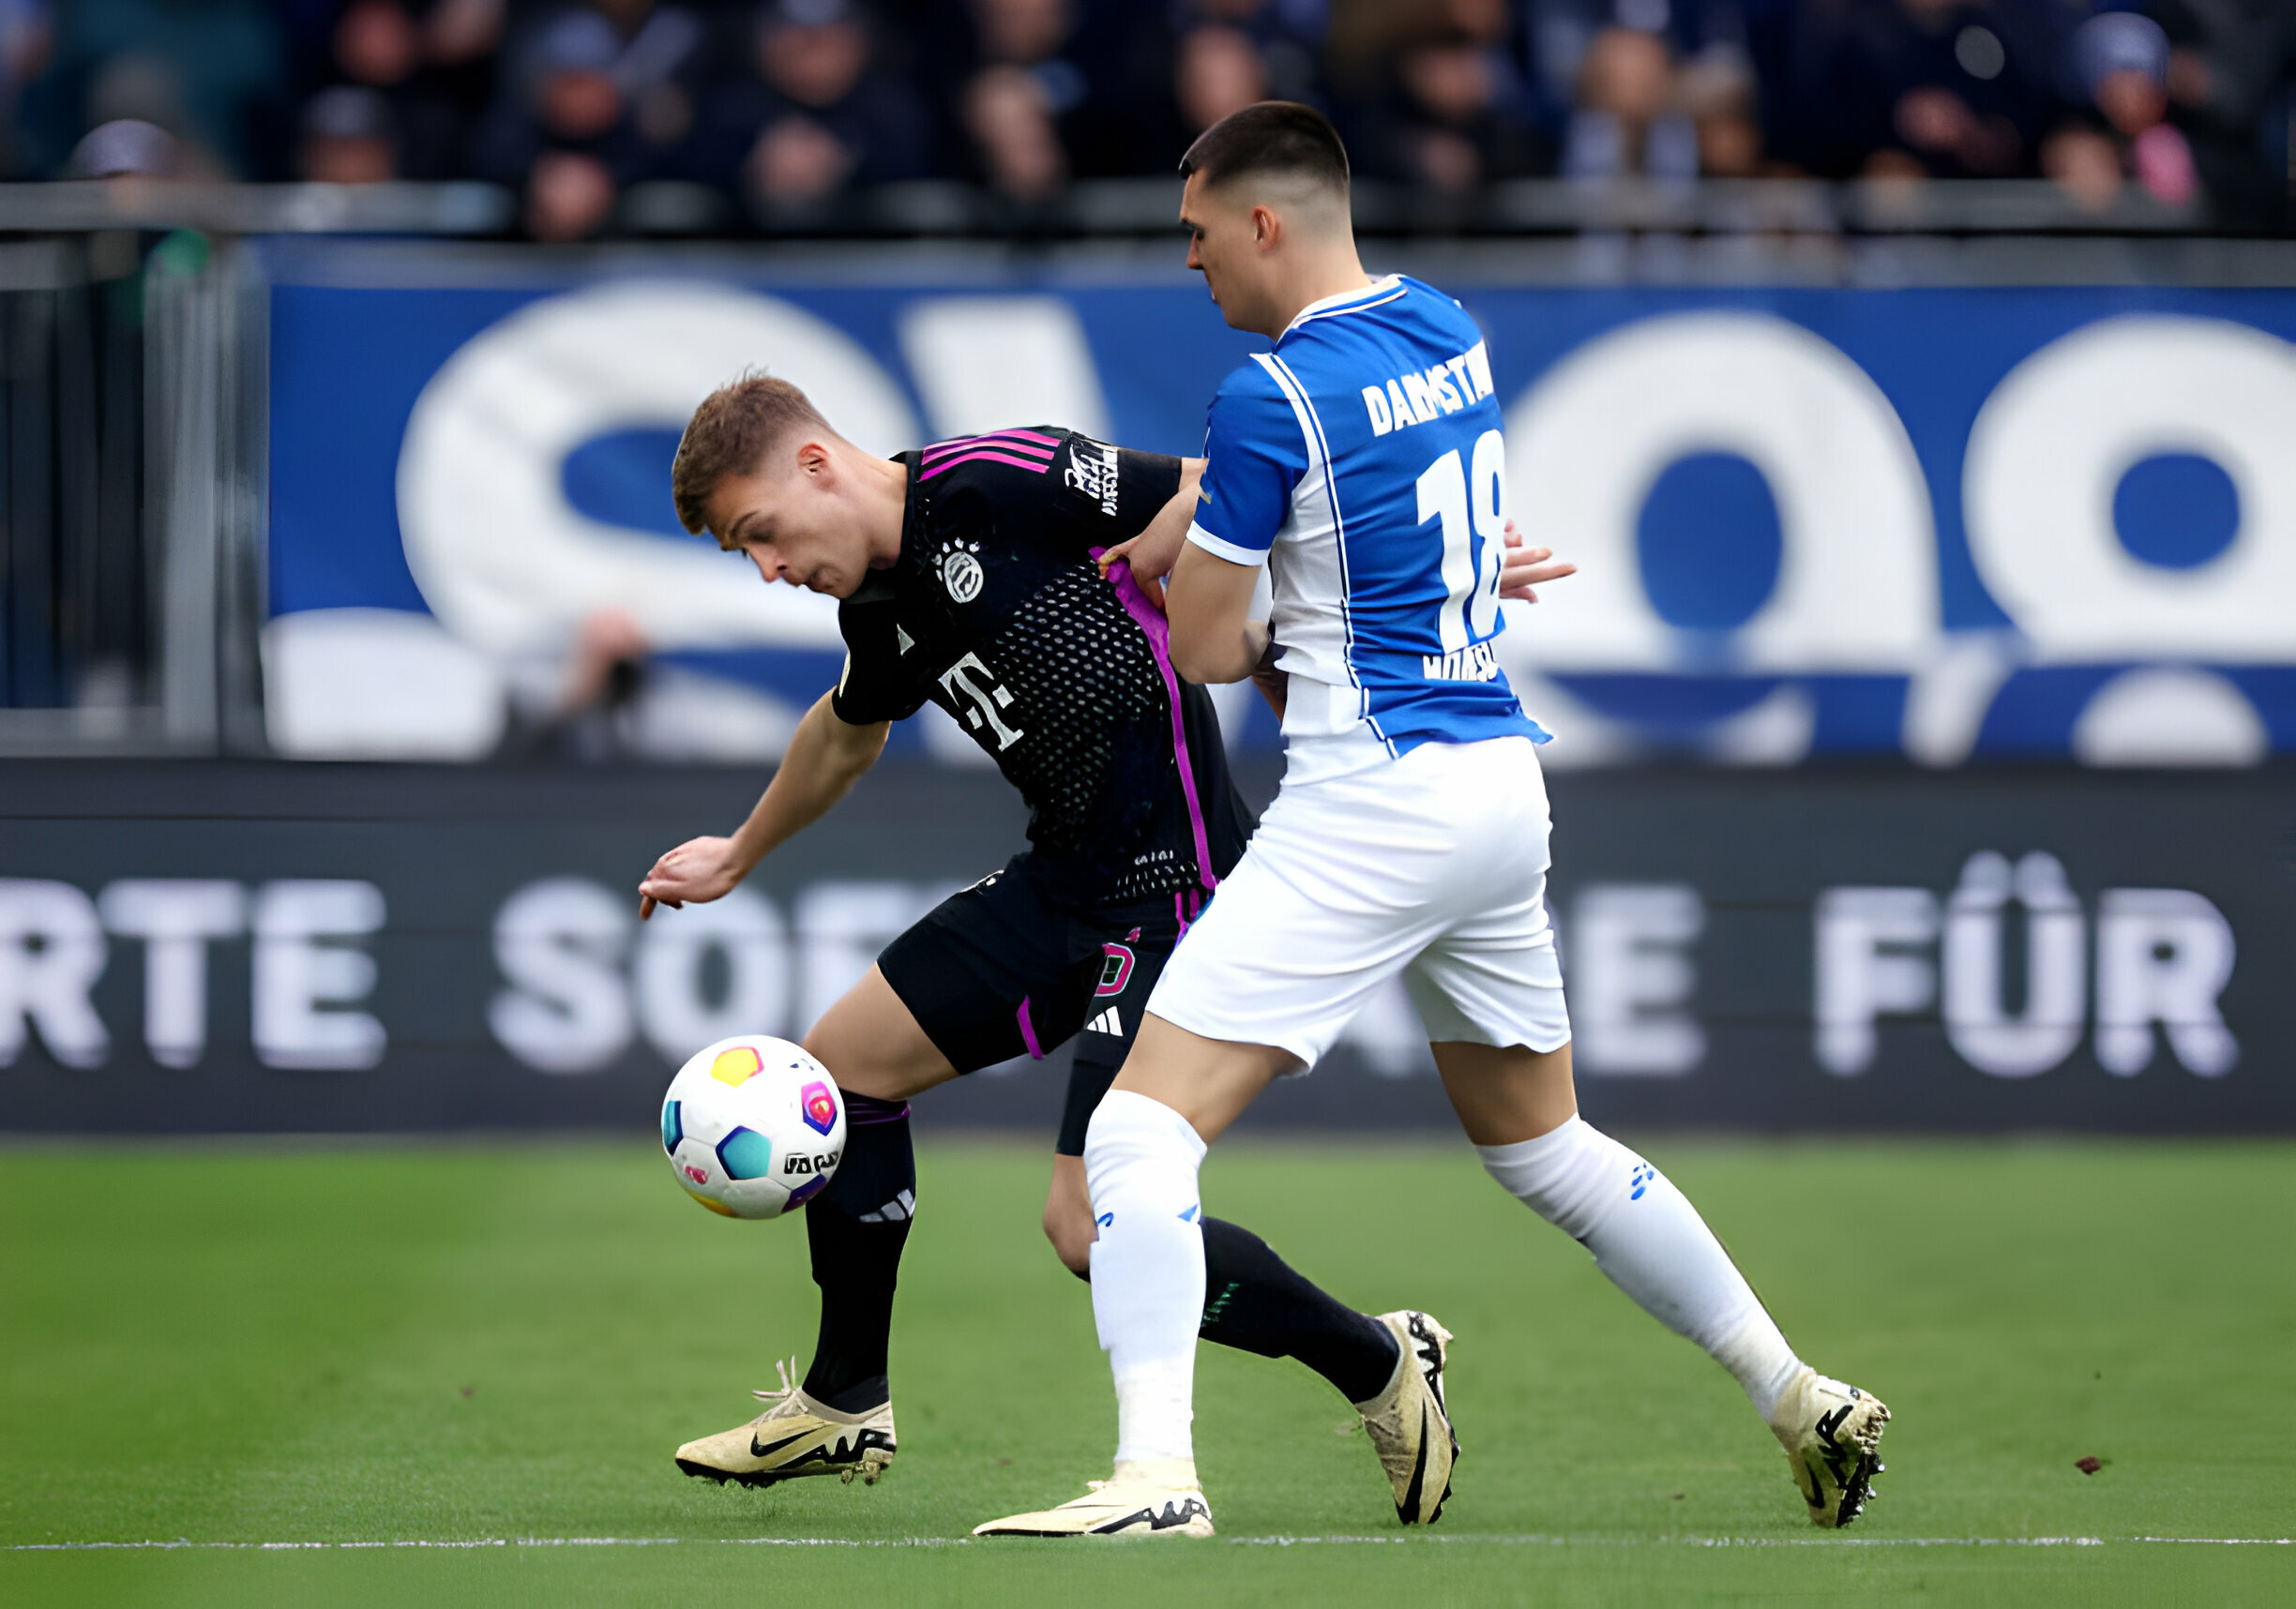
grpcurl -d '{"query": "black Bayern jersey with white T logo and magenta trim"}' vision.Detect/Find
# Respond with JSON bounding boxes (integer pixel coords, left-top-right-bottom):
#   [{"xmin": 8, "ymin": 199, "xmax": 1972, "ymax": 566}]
[{"xmin": 831, "ymin": 425, "xmax": 1246, "ymax": 907}]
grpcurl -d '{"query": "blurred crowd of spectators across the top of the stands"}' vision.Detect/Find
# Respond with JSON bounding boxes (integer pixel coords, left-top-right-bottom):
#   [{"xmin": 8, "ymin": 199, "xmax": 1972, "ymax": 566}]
[{"xmin": 0, "ymin": 0, "xmax": 2296, "ymax": 241}]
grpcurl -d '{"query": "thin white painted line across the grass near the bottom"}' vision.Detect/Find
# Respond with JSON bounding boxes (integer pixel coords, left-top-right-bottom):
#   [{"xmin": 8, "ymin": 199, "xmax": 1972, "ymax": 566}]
[{"xmin": 5, "ymin": 1533, "xmax": 2296, "ymax": 1554}]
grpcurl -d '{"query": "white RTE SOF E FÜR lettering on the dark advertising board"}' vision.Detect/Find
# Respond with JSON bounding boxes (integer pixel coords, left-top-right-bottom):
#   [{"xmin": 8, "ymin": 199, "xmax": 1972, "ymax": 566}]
[{"xmin": 0, "ymin": 850, "xmax": 2241, "ymax": 1079}]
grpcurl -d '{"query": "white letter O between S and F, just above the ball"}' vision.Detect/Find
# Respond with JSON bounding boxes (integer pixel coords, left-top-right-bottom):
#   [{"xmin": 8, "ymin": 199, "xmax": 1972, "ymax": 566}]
[{"xmin": 634, "ymin": 888, "xmax": 790, "ymax": 1067}]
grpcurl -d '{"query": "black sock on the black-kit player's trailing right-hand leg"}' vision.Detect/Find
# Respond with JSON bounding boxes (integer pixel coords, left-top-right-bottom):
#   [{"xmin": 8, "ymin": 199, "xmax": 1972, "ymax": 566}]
[{"xmin": 1196, "ymin": 1219, "xmax": 1400, "ymax": 1403}]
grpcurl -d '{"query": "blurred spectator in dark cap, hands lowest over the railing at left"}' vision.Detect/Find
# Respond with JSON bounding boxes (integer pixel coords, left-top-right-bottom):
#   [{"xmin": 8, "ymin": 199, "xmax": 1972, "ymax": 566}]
[{"xmin": 476, "ymin": 0, "xmax": 702, "ymax": 241}]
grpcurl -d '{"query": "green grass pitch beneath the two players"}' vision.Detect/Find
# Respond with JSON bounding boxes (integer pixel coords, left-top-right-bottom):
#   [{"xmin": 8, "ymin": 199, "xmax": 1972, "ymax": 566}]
[{"xmin": 0, "ymin": 1136, "xmax": 2296, "ymax": 1609}]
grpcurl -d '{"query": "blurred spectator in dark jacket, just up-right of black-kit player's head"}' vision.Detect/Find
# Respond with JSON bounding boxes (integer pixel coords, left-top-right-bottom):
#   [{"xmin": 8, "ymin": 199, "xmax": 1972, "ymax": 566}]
[{"xmin": 696, "ymin": 0, "xmax": 932, "ymax": 209}]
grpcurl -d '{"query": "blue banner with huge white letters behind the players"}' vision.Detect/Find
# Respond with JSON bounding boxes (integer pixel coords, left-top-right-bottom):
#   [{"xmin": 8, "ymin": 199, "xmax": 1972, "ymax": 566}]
[{"xmin": 266, "ymin": 260, "xmax": 2296, "ymax": 767}]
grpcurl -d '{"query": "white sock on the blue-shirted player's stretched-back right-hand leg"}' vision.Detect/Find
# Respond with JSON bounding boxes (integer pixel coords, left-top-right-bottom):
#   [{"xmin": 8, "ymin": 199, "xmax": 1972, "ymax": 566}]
[{"xmin": 1474, "ymin": 1118, "xmax": 1803, "ymax": 1419}]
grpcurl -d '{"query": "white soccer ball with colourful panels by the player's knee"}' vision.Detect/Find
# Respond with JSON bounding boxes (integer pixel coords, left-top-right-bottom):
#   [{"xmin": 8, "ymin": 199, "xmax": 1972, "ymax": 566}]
[{"xmin": 661, "ymin": 1033, "xmax": 845, "ymax": 1219}]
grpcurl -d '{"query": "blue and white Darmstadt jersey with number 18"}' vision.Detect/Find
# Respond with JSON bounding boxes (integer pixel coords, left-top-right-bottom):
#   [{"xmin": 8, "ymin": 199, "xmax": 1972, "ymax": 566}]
[{"xmin": 1187, "ymin": 276, "xmax": 1548, "ymax": 783}]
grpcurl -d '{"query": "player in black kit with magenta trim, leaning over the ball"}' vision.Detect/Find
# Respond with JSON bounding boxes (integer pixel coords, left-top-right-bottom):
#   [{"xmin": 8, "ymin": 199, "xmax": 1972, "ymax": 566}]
[{"xmin": 641, "ymin": 376, "xmax": 1570, "ymax": 1524}]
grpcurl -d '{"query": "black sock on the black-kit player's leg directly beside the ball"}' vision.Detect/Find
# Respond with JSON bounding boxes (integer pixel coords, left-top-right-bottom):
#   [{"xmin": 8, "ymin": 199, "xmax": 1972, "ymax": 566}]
[{"xmin": 806, "ymin": 1095, "xmax": 916, "ymax": 1414}]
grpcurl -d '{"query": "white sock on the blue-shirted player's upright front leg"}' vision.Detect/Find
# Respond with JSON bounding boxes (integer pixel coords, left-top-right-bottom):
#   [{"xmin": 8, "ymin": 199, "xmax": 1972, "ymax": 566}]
[{"xmin": 1083, "ymin": 1090, "xmax": 1203, "ymax": 1465}]
